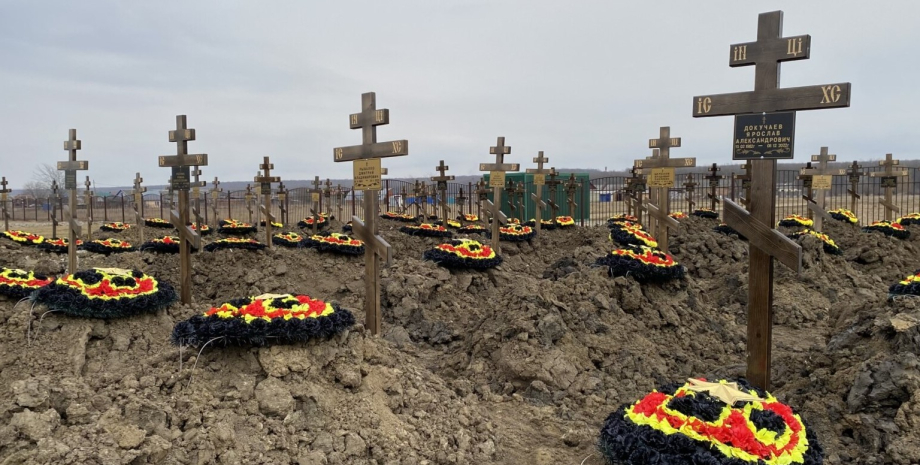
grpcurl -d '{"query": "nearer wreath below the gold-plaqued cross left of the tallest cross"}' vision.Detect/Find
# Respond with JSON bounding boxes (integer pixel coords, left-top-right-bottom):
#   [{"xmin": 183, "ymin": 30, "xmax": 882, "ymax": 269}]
[{"xmin": 596, "ymin": 246, "xmax": 684, "ymax": 282}]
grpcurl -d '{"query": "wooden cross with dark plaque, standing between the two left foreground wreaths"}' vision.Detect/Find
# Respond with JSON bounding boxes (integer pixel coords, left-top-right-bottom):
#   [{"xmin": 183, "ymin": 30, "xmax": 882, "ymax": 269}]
[{"xmin": 159, "ymin": 115, "xmax": 208, "ymax": 304}]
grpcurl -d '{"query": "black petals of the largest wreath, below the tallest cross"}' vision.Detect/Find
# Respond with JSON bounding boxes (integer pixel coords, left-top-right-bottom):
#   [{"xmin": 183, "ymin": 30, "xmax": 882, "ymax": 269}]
[{"xmin": 597, "ymin": 379, "xmax": 824, "ymax": 465}]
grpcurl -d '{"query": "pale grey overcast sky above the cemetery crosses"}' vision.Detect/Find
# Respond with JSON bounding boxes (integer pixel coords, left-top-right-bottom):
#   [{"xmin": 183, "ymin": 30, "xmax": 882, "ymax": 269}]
[{"xmin": 0, "ymin": 0, "xmax": 920, "ymax": 187}]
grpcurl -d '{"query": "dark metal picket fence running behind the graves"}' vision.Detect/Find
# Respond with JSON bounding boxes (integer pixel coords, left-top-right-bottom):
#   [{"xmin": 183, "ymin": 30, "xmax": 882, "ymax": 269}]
[{"xmin": 7, "ymin": 165, "xmax": 920, "ymax": 225}]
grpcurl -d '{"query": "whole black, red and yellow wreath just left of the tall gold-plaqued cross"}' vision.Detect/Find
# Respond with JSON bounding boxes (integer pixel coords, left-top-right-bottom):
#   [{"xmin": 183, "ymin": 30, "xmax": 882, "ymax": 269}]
[{"xmin": 171, "ymin": 294, "xmax": 355, "ymax": 347}]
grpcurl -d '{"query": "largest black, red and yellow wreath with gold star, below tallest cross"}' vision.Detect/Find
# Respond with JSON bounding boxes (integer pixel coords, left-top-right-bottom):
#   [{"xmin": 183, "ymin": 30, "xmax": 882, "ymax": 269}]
[{"xmin": 598, "ymin": 379, "xmax": 824, "ymax": 465}]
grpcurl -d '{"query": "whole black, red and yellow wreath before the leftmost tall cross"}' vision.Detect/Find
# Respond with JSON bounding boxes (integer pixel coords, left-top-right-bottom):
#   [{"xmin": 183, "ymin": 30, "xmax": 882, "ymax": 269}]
[{"xmin": 32, "ymin": 268, "xmax": 177, "ymax": 318}]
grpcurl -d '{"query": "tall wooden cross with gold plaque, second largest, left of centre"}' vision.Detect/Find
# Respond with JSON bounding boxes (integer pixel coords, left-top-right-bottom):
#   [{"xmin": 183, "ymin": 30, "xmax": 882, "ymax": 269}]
[{"xmin": 333, "ymin": 92, "xmax": 409, "ymax": 335}]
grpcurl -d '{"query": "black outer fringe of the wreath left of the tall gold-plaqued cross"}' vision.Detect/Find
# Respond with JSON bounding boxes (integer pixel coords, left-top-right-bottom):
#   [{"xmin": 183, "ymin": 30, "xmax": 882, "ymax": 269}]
[{"xmin": 171, "ymin": 299, "xmax": 355, "ymax": 347}]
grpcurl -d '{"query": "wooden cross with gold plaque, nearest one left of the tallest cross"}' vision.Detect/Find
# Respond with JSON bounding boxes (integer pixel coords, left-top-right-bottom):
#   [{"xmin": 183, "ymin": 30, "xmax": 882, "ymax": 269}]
[{"xmin": 634, "ymin": 126, "xmax": 696, "ymax": 252}]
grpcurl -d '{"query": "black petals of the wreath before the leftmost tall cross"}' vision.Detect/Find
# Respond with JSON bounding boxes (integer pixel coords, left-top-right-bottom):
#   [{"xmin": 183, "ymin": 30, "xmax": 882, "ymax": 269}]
[{"xmin": 31, "ymin": 270, "xmax": 179, "ymax": 319}]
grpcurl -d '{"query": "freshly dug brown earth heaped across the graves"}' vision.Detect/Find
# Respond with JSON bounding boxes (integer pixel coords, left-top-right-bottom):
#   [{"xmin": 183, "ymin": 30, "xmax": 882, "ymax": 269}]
[{"xmin": 0, "ymin": 217, "xmax": 920, "ymax": 465}]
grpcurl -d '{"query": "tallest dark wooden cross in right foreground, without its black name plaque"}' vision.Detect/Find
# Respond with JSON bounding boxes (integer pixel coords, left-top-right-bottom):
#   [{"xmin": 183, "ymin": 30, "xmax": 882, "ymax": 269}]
[{"xmin": 693, "ymin": 11, "xmax": 850, "ymax": 389}]
